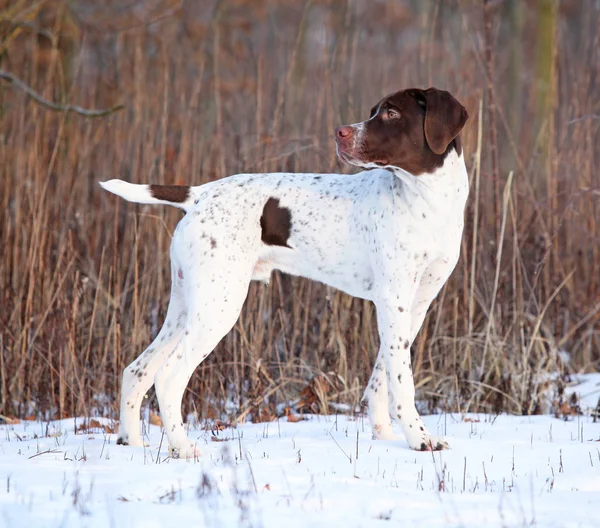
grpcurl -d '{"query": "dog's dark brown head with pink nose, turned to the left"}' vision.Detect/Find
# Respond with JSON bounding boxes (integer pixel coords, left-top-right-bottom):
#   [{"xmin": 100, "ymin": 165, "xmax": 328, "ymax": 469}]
[{"xmin": 335, "ymin": 88, "xmax": 468, "ymax": 175}]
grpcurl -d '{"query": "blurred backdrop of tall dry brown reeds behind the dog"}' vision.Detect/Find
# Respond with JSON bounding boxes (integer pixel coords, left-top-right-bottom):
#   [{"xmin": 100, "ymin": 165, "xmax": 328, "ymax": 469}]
[{"xmin": 0, "ymin": 0, "xmax": 600, "ymax": 421}]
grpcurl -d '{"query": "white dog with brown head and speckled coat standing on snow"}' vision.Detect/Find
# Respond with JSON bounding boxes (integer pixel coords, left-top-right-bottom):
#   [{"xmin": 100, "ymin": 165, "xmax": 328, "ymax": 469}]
[{"xmin": 100, "ymin": 88, "xmax": 469, "ymax": 458}]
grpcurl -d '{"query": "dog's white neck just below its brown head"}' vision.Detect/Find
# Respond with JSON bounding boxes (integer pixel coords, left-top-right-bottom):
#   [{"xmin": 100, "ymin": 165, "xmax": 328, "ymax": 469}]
[{"xmin": 390, "ymin": 149, "xmax": 469, "ymax": 222}]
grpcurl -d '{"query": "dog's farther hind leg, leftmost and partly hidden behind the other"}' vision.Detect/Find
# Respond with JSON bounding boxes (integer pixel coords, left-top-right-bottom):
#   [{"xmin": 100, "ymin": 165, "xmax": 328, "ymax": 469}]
[{"xmin": 117, "ymin": 265, "xmax": 187, "ymax": 446}]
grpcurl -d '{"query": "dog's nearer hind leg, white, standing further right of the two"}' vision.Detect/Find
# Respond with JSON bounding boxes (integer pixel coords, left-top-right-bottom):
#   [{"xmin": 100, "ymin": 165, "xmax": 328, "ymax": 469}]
[{"xmin": 154, "ymin": 255, "xmax": 254, "ymax": 458}]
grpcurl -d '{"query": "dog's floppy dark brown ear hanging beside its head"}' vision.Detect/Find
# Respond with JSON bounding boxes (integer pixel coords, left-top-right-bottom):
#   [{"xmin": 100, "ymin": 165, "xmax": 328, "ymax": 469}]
[{"xmin": 422, "ymin": 88, "xmax": 469, "ymax": 154}]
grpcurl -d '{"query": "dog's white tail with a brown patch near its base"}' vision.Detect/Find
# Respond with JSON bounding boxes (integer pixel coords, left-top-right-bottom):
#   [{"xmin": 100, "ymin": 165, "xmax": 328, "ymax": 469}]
[{"xmin": 100, "ymin": 180, "xmax": 194, "ymax": 212}]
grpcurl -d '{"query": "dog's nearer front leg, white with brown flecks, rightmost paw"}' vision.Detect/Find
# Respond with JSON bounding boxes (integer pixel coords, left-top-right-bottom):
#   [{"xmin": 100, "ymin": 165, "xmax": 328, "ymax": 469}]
[{"xmin": 376, "ymin": 302, "xmax": 448, "ymax": 451}]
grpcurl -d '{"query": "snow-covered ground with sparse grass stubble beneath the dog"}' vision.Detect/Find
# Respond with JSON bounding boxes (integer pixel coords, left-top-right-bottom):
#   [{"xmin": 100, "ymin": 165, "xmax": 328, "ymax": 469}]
[{"xmin": 0, "ymin": 378, "xmax": 600, "ymax": 528}]
